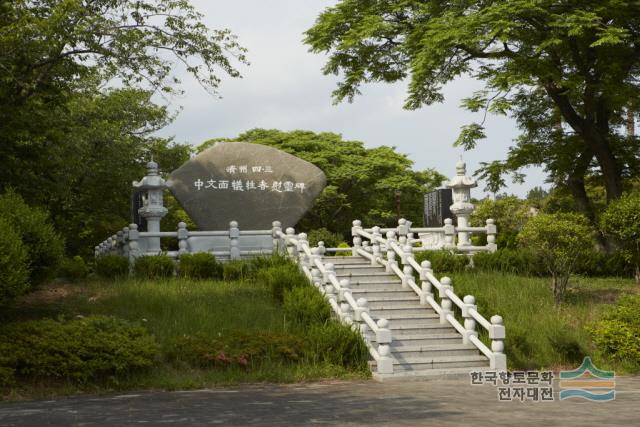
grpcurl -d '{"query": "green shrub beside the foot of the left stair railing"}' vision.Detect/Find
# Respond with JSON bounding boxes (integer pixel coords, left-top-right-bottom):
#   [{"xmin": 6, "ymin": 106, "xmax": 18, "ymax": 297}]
[{"xmin": 305, "ymin": 321, "xmax": 369, "ymax": 370}]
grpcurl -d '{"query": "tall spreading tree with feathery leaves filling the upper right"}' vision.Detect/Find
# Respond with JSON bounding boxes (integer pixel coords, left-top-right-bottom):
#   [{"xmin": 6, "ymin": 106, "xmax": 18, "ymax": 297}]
[{"xmin": 305, "ymin": 0, "xmax": 640, "ymax": 207}]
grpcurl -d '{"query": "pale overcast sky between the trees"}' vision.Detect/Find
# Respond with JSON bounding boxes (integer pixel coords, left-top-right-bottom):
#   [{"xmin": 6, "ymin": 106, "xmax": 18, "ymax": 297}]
[{"xmin": 159, "ymin": 0, "xmax": 547, "ymax": 197}]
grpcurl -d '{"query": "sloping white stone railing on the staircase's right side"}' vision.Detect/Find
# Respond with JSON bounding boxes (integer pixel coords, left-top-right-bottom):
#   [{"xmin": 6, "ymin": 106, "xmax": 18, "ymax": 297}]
[{"xmin": 351, "ymin": 220, "xmax": 507, "ymax": 370}]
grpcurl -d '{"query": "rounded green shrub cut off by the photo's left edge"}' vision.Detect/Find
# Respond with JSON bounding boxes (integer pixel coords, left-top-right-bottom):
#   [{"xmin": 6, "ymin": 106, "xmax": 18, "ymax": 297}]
[{"xmin": 0, "ymin": 218, "xmax": 29, "ymax": 306}]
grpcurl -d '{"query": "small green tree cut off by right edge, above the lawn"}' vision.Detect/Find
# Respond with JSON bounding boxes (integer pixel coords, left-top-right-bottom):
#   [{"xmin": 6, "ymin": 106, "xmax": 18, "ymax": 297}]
[{"xmin": 600, "ymin": 193, "xmax": 640, "ymax": 283}]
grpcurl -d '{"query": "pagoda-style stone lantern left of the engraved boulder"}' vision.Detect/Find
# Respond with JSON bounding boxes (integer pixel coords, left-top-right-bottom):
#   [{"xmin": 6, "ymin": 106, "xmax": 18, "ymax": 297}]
[{"xmin": 133, "ymin": 160, "xmax": 169, "ymax": 253}]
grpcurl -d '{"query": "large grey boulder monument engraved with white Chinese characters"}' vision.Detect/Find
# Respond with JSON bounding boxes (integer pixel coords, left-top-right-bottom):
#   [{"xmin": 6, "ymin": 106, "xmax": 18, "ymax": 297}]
[{"xmin": 168, "ymin": 142, "xmax": 326, "ymax": 230}]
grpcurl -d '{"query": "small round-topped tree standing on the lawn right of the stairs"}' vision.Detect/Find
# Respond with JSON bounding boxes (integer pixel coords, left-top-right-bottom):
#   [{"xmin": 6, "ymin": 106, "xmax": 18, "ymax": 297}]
[{"xmin": 518, "ymin": 214, "xmax": 593, "ymax": 304}]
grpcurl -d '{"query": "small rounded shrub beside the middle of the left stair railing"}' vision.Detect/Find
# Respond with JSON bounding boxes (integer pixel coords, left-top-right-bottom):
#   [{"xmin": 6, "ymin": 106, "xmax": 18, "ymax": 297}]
[{"xmin": 282, "ymin": 285, "xmax": 331, "ymax": 325}]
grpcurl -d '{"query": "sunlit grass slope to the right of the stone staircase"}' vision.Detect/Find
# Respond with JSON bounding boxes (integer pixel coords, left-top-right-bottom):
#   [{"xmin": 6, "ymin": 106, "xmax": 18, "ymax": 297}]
[{"xmin": 450, "ymin": 272, "xmax": 640, "ymax": 373}]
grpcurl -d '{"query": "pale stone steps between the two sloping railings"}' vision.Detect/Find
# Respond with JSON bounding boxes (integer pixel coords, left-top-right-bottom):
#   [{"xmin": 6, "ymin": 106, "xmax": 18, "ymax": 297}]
[{"xmin": 332, "ymin": 256, "xmax": 489, "ymax": 379}]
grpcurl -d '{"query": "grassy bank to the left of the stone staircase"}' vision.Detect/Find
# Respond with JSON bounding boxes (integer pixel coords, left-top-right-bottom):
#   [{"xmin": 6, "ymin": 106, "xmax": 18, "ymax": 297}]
[{"xmin": 0, "ymin": 279, "xmax": 370, "ymax": 399}]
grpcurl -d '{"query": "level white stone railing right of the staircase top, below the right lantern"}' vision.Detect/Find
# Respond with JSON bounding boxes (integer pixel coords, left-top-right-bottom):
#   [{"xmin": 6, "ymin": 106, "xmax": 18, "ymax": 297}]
[{"xmin": 364, "ymin": 218, "xmax": 498, "ymax": 254}]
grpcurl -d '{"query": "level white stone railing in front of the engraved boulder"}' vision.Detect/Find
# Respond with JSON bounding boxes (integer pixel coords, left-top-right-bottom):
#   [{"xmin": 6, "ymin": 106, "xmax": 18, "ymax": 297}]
[{"xmin": 94, "ymin": 221, "xmax": 281, "ymax": 263}]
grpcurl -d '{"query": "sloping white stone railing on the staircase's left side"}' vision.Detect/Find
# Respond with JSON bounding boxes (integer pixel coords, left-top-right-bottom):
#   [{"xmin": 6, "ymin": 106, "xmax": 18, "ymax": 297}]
[{"xmin": 277, "ymin": 228, "xmax": 394, "ymax": 374}]
